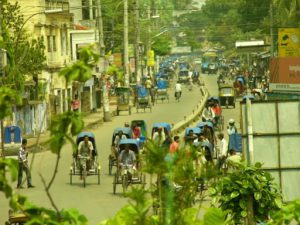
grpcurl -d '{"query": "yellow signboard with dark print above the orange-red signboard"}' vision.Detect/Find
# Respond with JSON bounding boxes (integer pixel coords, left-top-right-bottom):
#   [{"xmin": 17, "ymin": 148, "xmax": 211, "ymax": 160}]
[{"xmin": 278, "ymin": 28, "xmax": 300, "ymax": 57}]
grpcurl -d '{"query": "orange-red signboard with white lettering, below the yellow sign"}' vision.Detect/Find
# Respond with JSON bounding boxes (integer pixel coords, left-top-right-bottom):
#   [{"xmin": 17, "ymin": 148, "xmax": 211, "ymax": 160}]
[{"xmin": 270, "ymin": 57, "xmax": 300, "ymax": 91}]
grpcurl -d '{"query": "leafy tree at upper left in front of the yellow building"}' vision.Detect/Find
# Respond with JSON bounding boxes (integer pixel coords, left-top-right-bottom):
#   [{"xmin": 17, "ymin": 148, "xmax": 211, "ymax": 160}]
[{"xmin": 0, "ymin": 2, "xmax": 46, "ymax": 97}]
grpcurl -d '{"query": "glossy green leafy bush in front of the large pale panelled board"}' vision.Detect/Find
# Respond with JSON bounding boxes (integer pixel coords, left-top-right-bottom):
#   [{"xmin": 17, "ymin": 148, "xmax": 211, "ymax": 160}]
[{"xmin": 209, "ymin": 164, "xmax": 281, "ymax": 223}]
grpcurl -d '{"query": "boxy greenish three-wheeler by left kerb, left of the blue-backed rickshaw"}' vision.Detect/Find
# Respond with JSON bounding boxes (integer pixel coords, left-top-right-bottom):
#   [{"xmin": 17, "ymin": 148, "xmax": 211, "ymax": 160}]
[{"xmin": 116, "ymin": 87, "xmax": 131, "ymax": 115}]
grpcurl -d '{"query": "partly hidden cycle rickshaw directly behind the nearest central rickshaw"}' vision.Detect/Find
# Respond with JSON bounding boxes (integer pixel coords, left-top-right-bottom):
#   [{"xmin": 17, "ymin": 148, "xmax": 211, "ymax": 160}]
[{"xmin": 108, "ymin": 127, "xmax": 132, "ymax": 175}]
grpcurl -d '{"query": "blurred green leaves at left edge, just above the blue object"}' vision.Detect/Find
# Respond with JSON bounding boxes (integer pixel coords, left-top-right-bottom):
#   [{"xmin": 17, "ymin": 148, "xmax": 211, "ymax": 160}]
[{"xmin": 0, "ymin": 87, "xmax": 22, "ymax": 119}]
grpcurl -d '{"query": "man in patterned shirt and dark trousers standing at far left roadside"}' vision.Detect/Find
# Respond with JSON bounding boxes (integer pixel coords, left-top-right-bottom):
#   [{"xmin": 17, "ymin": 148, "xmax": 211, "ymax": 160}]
[{"xmin": 17, "ymin": 139, "xmax": 34, "ymax": 188}]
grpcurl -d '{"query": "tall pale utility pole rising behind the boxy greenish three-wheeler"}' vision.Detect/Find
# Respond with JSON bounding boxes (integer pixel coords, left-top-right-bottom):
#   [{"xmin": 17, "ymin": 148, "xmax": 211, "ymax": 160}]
[{"xmin": 134, "ymin": 0, "xmax": 141, "ymax": 83}]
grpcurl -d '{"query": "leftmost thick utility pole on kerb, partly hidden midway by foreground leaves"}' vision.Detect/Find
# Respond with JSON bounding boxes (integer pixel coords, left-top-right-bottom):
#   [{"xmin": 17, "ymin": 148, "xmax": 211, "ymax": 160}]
[{"xmin": 97, "ymin": 0, "xmax": 111, "ymax": 122}]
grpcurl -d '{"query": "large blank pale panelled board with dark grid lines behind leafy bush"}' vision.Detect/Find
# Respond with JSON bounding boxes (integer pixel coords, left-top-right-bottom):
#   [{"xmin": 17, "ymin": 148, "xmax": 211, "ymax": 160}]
[{"xmin": 241, "ymin": 100, "xmax": 300, "ymax": 201}]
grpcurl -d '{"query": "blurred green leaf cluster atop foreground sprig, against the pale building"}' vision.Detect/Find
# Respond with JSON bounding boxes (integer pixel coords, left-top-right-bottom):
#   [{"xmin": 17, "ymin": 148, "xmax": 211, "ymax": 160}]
[{"xmin": 59, "ymin": 48, "xmax": 99, "ymax": 85}]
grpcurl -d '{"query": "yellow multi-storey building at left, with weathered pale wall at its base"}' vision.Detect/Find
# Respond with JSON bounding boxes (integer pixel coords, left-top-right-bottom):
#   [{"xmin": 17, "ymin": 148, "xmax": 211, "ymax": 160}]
[{"xmin": 8, "ymin": 0, "xmax": 73, "ymax": 134}]
